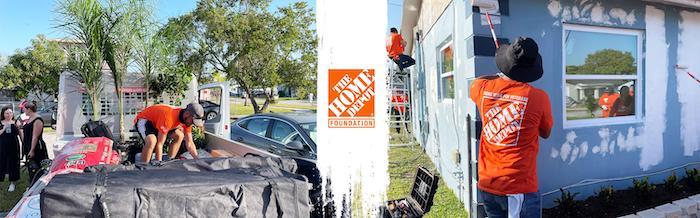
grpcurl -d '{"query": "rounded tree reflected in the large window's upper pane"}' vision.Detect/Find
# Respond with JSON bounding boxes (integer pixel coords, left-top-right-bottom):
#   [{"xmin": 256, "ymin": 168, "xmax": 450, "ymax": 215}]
[{"xmin": 566, "ymin": 49, "xmax": 637, "ymax": 75}]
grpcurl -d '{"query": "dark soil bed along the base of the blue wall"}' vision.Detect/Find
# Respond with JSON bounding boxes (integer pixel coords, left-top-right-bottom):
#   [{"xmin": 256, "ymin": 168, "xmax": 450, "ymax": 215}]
[{"xmin": 542, "ymin": 178, "xmax": 700, "ymax": 217}]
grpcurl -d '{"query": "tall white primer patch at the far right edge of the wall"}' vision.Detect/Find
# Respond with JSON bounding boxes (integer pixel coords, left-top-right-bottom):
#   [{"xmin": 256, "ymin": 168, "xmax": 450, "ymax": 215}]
[{"xmin": 675, "ymin": 11, "xmax": 700, "ymax": 156}]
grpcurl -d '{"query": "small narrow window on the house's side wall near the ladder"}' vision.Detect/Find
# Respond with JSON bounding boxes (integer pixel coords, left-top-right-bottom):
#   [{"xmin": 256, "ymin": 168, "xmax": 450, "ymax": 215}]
[{"xmin": 438, "ymin": 38, "xmax": 455, "ymax": 100}]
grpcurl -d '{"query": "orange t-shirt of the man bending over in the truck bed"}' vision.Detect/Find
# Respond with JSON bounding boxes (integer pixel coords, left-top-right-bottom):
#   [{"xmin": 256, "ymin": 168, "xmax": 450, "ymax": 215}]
[{"xmin": 134, "ymin": 104, "xmax": 192, "ymax": 134}]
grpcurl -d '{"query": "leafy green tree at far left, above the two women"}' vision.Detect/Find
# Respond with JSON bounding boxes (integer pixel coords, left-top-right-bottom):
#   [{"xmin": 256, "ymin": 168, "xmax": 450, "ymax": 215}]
[{"xmin": 0, "ymin": 35, "xmax": 66, "ymax": 102}]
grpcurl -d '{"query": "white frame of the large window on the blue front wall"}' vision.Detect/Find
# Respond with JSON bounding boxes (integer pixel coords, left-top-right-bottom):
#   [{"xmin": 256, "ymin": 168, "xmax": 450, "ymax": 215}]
[{"xmin": 561, "ymin": 23, "xmax": 646, "ymax": 129}]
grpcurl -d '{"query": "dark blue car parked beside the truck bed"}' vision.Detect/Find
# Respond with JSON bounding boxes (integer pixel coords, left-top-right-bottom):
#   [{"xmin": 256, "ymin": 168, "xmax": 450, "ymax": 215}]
[{"xmin": 231, "ymin": 112, "xmax": 316, "ymax": 160}]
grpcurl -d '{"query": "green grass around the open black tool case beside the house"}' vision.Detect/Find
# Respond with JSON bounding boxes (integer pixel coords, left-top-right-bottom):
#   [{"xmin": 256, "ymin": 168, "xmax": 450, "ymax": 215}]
[{"xmin": 387, "ymin": 146, "xmax": 469, "ymax": 218}]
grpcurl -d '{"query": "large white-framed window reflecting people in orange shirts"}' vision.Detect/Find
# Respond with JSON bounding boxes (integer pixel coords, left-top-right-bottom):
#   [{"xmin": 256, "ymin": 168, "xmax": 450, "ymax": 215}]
[{"xmin": 562, "ymin": 25, "xmax": 642, "ymax": 126}]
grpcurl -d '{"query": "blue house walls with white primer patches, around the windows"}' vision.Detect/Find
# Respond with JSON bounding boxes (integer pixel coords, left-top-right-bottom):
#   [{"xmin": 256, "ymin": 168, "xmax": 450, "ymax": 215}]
[{"xmin": 413, "ymin": 0, "xmax": 700, "ymax": 210}]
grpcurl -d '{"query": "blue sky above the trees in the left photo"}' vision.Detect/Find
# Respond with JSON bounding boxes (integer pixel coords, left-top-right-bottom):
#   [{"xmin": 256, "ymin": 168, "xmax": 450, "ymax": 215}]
[{"xmin": 0, "ymin": 0, "xmax": 314, "ymax": 56}]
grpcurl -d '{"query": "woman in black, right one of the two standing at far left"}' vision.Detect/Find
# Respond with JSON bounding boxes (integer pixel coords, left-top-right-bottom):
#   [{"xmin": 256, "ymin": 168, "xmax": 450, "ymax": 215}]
[{"xmin": 22, "ymin": 103, "xmax": 49, "ymax": 184}]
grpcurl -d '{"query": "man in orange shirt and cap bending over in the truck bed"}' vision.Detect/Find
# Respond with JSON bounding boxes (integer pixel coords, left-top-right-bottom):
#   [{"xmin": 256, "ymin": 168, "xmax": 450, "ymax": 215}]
[{"xmin": 134, "ymin": 103, "xmax": 204, "ymax": 163}]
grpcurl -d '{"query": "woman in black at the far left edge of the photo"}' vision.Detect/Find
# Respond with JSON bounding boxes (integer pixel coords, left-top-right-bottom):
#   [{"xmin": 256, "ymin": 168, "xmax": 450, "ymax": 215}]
[{"xmin": 0, "ymin": 107, "xmax": 19, "ymax": 192}]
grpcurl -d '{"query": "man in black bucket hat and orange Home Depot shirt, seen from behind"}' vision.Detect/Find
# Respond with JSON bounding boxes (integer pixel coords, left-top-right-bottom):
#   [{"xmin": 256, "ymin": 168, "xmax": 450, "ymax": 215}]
[{"xmin": 469, "ymin": 37, "xmax": 553, "ymax": 217}]
